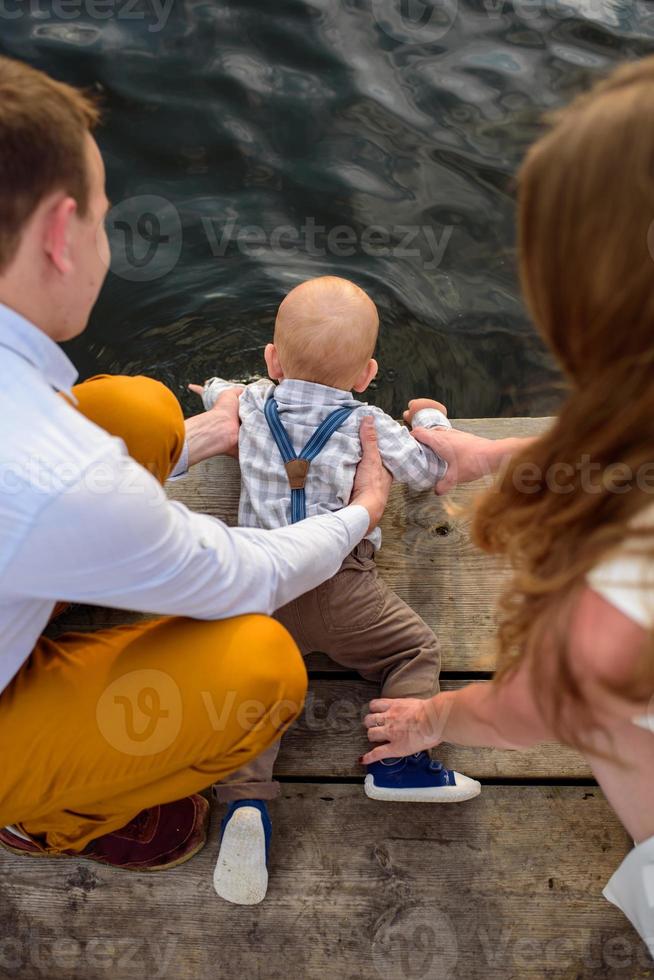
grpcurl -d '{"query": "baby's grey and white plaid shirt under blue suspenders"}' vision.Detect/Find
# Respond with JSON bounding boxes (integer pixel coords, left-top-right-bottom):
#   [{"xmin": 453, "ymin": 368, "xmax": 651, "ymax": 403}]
[{"xmin": 203, "ymin": 378, "xmax": 450, "ymax": 548}]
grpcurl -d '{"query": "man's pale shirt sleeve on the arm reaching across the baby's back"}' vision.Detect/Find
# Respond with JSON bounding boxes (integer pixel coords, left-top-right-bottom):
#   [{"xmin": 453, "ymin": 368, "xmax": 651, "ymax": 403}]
[{"xmin": 5, "ymin": 456, "xmax": 369, "ymax": 619}]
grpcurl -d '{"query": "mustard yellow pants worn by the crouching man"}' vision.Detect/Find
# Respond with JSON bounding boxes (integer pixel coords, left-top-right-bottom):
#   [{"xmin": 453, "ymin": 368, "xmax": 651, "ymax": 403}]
[{"xmin": 0, "ymin": 376, "xmax": 307, "ymax": 852}]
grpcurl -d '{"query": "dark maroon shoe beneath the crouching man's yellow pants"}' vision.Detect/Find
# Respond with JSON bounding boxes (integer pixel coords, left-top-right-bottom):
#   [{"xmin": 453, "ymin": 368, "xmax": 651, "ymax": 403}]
[{"xmin": 0, "ymin": 796, "xmax": 209, "ymax": 871}]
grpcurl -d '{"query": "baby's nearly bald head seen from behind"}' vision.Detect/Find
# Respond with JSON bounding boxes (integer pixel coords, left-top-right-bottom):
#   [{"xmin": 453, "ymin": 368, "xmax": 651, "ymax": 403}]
[{"xmin": 265, "ymin": 276, "xmax": 379, "ymax": 391}]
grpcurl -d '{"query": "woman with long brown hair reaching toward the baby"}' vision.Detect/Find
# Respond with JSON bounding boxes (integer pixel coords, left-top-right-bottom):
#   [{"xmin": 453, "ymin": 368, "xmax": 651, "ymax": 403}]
[{"xmin": 363, "ymin": 58, "xmax": 654, "ymax": 955}]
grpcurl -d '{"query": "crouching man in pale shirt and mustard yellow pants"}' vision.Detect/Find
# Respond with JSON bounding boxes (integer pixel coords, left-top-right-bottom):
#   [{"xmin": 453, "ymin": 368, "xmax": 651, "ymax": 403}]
[{"xmin": 0, "ymin": 58, "xmax": 390, "ymax": 870}]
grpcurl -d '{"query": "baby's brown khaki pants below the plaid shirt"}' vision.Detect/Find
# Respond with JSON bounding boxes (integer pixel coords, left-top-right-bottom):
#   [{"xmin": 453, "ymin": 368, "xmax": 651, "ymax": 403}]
[{"xmin": 214, "ymin": 541, "xmax": 440, "ymax": 802}]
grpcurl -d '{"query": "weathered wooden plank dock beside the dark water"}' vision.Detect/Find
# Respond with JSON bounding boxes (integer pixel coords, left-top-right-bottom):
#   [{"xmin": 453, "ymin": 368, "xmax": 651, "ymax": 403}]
[{"xmin": 0, "ymin": 419, "xmax": 654, "ymax": 980}]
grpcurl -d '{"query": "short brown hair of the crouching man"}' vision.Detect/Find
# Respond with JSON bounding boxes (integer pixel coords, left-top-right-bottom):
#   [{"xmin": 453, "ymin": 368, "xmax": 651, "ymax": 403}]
[{"xmin": 0, "ymin": 57, "xmax": 100, "ymax": 273}]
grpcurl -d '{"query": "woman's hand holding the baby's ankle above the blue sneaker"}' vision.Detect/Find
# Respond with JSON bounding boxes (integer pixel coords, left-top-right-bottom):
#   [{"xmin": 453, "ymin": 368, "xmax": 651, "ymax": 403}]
[{"xmin": 361, "ymin": 692, "xmax": 452, "ymax": 765}]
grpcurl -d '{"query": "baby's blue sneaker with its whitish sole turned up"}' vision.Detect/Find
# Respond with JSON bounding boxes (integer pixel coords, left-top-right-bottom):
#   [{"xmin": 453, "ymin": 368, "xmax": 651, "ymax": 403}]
[{"xmin": 213, "ymin": 800, "xmax": 272, "ymax": 905}]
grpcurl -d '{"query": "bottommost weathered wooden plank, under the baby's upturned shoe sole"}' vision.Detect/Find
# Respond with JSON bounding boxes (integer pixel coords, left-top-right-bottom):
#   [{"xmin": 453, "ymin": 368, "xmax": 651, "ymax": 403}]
[{"xmin": 0, "ymin": 784, "xmax": 640, "ymax": 980}]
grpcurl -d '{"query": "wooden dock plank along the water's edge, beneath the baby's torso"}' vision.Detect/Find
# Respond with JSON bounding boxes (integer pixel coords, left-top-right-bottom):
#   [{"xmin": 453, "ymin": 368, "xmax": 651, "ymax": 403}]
[{"xmin": 48, "ymin": 419, "xmax": 551, "ymax": 671}]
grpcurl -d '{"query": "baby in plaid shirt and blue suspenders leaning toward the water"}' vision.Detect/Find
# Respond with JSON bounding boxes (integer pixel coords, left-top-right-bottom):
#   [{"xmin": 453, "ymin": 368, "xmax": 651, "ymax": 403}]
[{"xmin": 194, "ymin": 276, "xmax": 481, "ymax": 905}]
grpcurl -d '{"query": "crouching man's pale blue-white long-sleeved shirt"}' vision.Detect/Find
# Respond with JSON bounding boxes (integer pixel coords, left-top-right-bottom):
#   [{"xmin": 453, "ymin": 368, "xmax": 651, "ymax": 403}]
[{"xmin": 0, "ymin": 305, "xmax": 369, "ymax": 690}]
